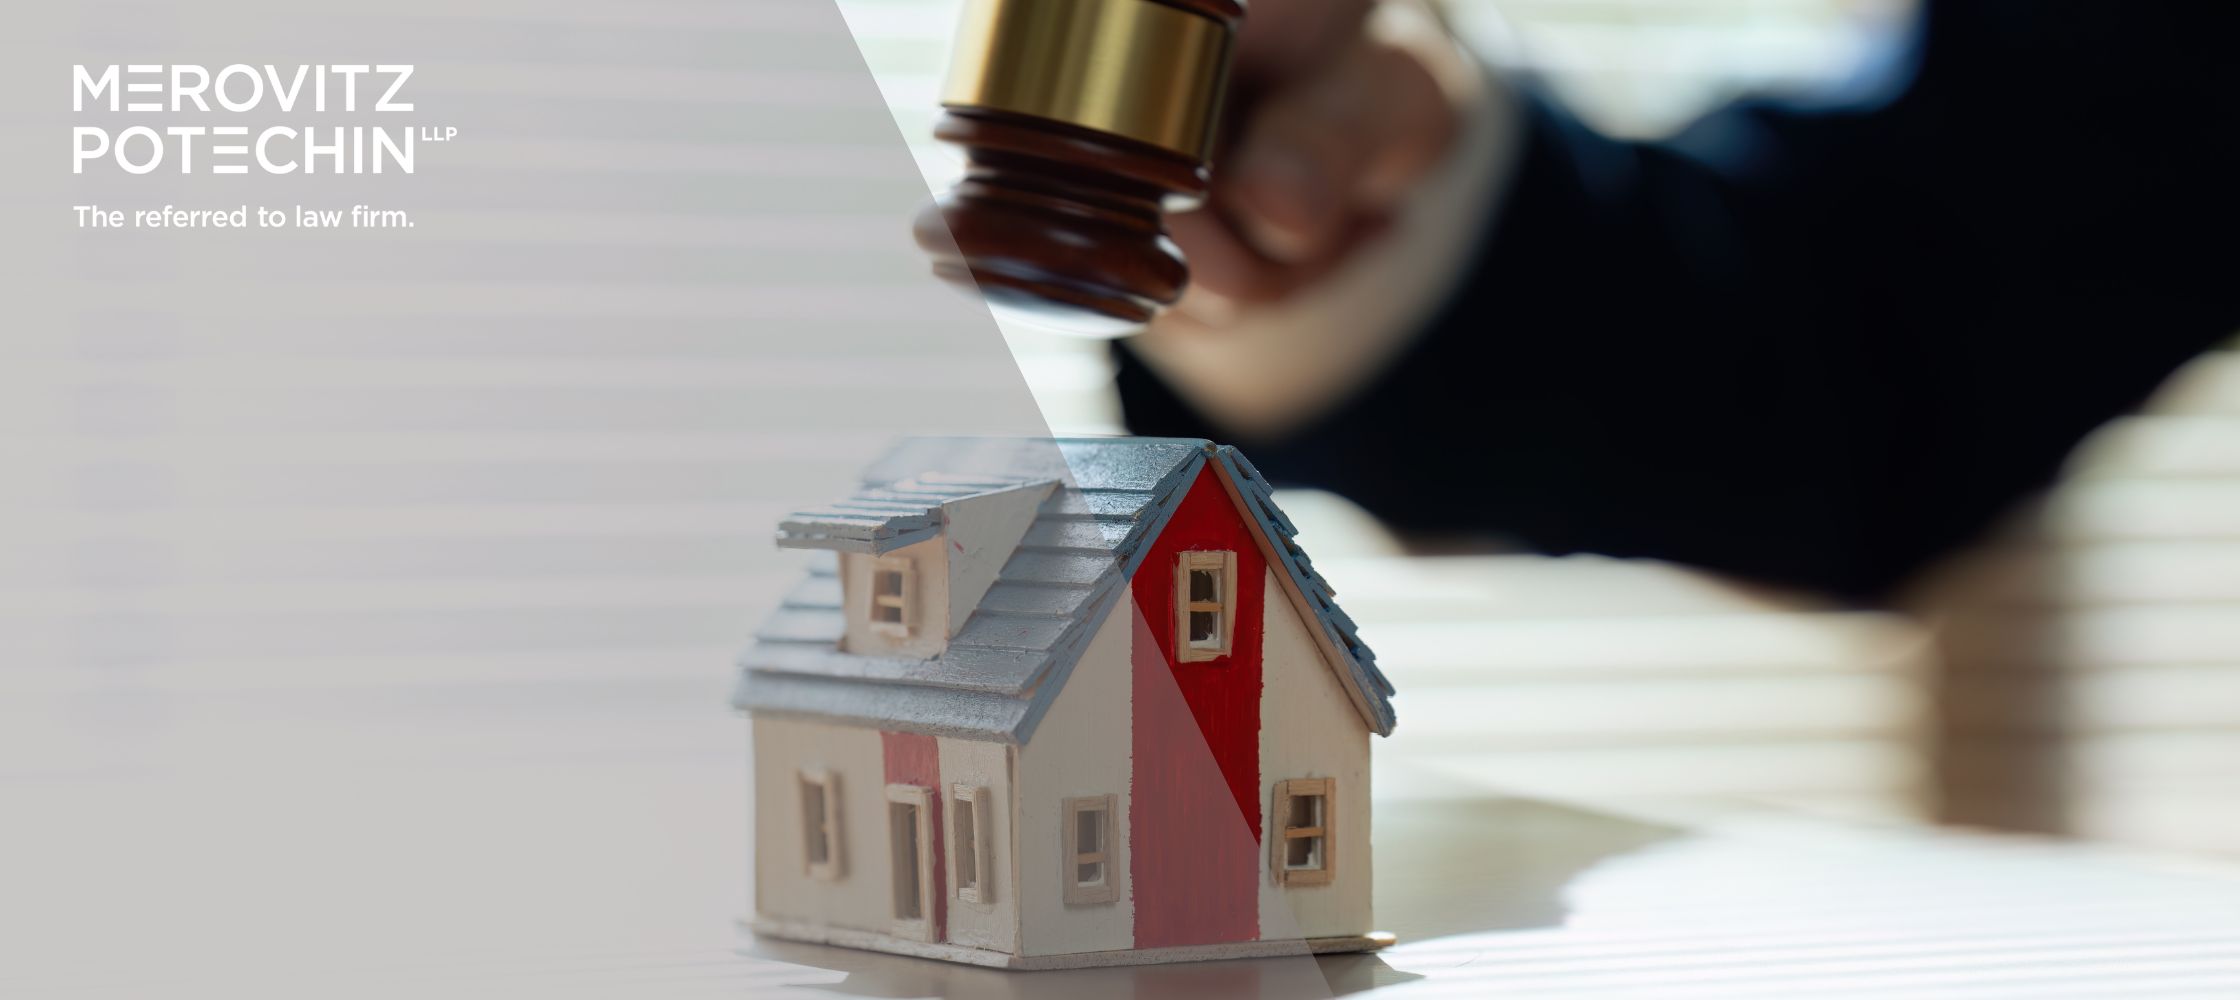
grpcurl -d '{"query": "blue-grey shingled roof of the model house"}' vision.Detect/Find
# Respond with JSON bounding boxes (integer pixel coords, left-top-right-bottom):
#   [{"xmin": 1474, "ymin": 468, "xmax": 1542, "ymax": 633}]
[{"xmin": 732, "ymin": 437, "xmax": 1393, "ymax": 742}]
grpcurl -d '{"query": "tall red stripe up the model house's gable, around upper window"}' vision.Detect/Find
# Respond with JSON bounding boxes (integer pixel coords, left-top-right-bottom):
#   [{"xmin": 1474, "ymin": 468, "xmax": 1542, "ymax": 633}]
[{"xmin": 1129, "ymin": 469, "xmax": 1268, "ymax": 948}]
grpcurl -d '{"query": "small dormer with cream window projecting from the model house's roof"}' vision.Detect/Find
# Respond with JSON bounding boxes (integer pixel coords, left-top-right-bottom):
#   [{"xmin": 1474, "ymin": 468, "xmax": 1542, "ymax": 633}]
[{"xmin": 777, "ymin": 473, "xmax": 1055, "ymax": 659}]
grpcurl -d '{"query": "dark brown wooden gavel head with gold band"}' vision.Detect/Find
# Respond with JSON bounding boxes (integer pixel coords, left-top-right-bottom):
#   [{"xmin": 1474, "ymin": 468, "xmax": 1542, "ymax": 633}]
[{"xmin": 916, "ymin": 0, "xmax": 1245, "ymax": 336}]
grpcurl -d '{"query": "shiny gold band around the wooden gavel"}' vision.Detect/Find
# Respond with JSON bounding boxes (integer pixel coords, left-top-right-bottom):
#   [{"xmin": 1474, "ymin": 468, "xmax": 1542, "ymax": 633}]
[{"xmin": 941, "ymin": 0, "xmax": 1230, "ymax": 161}]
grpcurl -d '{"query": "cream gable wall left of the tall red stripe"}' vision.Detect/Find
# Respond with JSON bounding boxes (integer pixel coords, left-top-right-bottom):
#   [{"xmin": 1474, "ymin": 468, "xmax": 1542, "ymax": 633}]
[{"xmin": 1015, "ymin": 596, "xmax": 1136, "ymax": 955}]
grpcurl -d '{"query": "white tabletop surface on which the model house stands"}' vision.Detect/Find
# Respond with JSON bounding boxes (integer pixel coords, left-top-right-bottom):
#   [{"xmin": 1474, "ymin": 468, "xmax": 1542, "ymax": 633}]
[{"xmin": 0, "ymin": 675, "xmax": 2240, "ymax": 1000}]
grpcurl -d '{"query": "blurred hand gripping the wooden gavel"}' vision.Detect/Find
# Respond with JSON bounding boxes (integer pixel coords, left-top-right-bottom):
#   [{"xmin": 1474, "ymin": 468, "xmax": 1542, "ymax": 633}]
[{"xmin": 1169, "ymin": 0, "xmax": 1474, "ymax": 325}]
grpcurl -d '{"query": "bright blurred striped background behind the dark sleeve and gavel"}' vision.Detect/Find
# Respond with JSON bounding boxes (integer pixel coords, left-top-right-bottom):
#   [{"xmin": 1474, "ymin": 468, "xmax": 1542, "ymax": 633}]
[{"xmin": 840, "ymin": 0, "xmax": 2240, "ymax": 852}]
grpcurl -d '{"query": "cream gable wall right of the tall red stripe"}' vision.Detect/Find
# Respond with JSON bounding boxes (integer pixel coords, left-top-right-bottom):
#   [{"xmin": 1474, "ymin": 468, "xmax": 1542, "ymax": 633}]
[{"xmin": 1259, "ymin": 570, "xmax": 1373, "ymax": 939}]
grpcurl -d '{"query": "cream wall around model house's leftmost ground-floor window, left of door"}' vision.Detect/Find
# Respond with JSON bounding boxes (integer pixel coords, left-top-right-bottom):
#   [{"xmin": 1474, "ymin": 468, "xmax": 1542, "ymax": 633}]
[{"xmin": 750, "ymin": 717, "xmax": 894, "ymax": 933}]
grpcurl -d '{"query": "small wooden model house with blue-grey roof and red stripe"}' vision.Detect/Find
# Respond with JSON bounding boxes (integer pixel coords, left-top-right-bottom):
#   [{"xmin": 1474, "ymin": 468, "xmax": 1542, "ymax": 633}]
[{"xmin": 735, "ymin": 437, "xmax": 1393, "ymax": 969}]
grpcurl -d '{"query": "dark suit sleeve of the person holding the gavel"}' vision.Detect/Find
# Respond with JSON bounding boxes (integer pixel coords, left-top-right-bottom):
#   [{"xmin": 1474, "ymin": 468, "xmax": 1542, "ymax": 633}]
[{"xmin": 1120, "ymin": 0, "xmax": 2240, "ymax": 601}]
